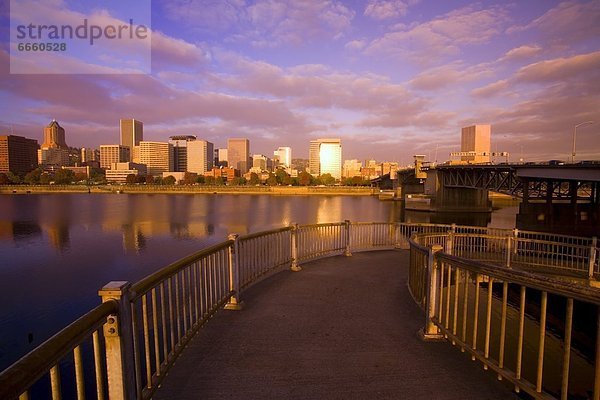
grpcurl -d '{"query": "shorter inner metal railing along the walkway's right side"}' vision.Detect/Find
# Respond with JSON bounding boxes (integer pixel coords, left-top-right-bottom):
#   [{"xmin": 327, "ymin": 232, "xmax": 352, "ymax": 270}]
[{"xmin": 408, "ymin": 232, "xmax": 600, "ymax": 399}]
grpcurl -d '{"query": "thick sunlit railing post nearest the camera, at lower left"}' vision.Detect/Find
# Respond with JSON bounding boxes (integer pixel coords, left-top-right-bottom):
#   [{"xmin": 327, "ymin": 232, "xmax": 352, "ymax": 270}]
[{"xmin": 98, "ymin": 281, "xmax": 136, "ymax": 400}]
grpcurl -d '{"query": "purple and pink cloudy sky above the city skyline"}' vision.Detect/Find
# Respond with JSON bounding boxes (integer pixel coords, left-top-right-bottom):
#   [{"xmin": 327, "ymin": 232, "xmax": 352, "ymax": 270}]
[{"xmin": 0, "ymin": 0, "xmax": 600, "ymax": 164}]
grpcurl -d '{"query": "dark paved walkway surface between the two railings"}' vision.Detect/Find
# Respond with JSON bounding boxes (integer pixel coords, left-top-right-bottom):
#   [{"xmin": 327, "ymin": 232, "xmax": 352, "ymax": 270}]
[{"xmin": 154, "ymin": 251, "xmax": 517, "ymax": 400}]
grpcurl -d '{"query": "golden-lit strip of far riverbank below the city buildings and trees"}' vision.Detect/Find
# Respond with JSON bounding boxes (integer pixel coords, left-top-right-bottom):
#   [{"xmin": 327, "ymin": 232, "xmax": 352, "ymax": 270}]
[{"xmin": 0, "ymin": 185, "xmax": 379, "ymax": 196}]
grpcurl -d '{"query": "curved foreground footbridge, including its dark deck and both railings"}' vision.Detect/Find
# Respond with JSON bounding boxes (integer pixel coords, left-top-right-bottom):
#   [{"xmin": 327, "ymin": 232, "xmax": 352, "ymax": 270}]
[{"xmin": 0, "ymin": 221, "xmax": 600, "ymax": 399}]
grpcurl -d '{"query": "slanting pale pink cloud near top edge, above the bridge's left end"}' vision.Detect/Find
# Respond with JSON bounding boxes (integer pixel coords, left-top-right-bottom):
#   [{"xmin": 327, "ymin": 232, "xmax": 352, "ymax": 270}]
[{"xmin": 365, "ymin": 6, "xmax": 508, "ymax": 65}]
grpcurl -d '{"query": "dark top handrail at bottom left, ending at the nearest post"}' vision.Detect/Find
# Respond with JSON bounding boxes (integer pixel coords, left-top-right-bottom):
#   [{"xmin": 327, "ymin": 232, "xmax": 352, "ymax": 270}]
[{"xmin": 0, "ymin": 300, "xmax": 118, "ymax": 399}]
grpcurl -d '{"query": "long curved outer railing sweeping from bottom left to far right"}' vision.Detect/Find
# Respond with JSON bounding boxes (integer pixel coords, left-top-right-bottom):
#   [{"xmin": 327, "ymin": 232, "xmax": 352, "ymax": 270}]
[{"xmin": 0, "ymin": 221, "xmax": 600, "ymax": 399}]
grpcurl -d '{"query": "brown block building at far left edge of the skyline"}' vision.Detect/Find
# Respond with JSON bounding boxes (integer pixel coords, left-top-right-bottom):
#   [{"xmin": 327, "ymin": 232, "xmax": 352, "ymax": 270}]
[{"xmin": 0, "ymin": 135, "xmax": 38, "ymax": 175}]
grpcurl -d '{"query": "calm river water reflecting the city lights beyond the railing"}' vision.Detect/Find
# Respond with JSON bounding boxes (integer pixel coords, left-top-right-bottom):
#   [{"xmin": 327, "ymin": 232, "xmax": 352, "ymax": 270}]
[{"xmin": 0, "ymin": 194, "xmax": 517, "ymax": 370}]
